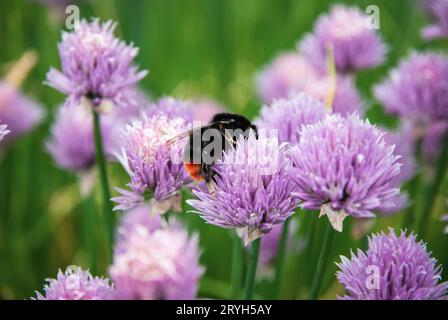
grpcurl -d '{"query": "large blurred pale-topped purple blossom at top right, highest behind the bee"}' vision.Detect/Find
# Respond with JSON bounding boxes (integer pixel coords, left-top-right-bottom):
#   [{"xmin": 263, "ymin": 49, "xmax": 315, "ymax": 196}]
[{"xmin": 300, "ymin": 5, "xmax": 387, "ymax": 73}]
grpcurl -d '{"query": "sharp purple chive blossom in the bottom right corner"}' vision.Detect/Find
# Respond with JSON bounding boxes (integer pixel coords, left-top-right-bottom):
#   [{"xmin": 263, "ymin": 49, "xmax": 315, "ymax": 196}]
[{"xmin": 337, "ymin": 229, "xmax": 448, "ymax": 300}]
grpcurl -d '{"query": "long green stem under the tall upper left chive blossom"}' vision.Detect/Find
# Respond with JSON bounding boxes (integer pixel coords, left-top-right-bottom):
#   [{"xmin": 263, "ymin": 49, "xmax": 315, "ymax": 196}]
[{"xmin": 92, "ymin": 109, "xmax": 115, "ymax": 261}]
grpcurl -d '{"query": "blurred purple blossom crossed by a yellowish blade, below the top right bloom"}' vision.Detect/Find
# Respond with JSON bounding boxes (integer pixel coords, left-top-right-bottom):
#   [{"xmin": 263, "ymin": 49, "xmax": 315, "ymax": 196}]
[{"xmin": 303, "ymin": 76, "xmax": 364, "ymax": 116}]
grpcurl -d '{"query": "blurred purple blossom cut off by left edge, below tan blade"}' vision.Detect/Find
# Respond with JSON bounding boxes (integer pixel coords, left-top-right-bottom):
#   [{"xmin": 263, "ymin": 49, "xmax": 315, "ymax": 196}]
[{"xmin": 0, "ymin": 81, "xmax": 45, "ymax": 144}]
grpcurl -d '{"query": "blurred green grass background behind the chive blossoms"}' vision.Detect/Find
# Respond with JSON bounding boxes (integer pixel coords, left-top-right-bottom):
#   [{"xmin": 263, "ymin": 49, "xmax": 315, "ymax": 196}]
[{"xmin": 0, "ymin": 0, "xmax": 448, "ymax": 299}]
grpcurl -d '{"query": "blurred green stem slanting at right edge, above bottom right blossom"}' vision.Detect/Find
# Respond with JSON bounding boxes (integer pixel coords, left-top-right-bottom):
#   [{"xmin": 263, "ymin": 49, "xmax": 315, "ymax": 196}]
[{"xmin": 416, "ymin": 134, "xmax": 448, "ymax": 238}]
